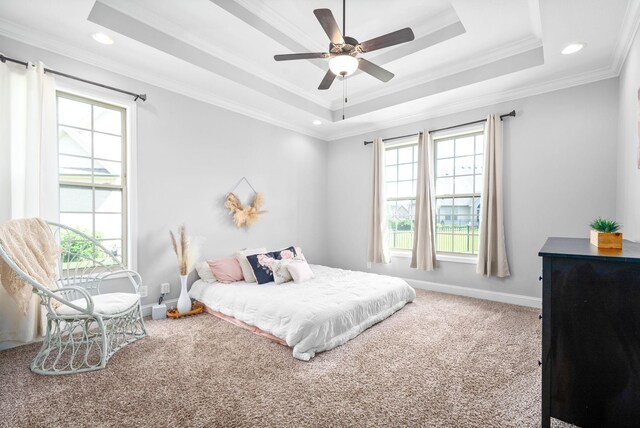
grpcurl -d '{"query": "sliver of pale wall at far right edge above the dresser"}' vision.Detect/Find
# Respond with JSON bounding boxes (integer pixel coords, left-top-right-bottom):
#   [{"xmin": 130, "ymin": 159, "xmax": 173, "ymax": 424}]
[{"xmin": 616, "ymin": 25, "xmax": 640, "ymax": 241}]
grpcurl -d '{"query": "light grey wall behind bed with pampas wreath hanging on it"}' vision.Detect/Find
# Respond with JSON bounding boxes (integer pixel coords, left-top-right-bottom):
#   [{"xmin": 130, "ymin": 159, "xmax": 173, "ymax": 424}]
[{"xmin": 0, "ymin": 37, "xmax": 328, "ymax": 304}]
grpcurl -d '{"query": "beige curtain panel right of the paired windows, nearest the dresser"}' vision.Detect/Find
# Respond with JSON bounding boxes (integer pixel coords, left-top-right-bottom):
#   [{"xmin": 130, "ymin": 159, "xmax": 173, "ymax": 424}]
[{"xmin": 477, "ymin": 114, "xmax": 510, "ymax": 277}]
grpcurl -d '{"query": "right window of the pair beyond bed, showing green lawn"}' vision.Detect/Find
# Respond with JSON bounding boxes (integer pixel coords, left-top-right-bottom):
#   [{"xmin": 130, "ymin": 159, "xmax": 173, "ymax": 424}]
[{"xmin": 434, "ymin": 131, "xmax": 484, "ymax": 254}]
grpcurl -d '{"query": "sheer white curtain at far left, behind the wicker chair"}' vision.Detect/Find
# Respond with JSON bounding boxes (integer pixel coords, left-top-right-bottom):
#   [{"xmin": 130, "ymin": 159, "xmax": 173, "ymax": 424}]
[{"xmin": 0, "ymin": 62, "xmax": 58, "ymax": 348}]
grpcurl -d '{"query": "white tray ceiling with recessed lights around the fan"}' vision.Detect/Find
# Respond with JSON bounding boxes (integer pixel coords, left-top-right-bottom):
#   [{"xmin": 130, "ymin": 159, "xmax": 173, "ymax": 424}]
[{"xmin": 0, "ymin": 0, "xmax": 640, "ymax": 140}]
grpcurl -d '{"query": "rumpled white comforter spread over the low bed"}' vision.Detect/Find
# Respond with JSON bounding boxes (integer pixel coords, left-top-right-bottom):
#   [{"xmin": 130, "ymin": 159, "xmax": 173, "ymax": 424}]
[{"xmin": 189, "ymin": 265, "xmax": 416, "ymax": 361}]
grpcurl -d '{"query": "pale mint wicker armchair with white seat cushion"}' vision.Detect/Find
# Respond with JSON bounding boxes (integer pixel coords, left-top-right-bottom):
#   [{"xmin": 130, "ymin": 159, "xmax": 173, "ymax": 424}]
[{"xmin": 0, "ymin": 222, "xmax": 147, "ymax": 375}]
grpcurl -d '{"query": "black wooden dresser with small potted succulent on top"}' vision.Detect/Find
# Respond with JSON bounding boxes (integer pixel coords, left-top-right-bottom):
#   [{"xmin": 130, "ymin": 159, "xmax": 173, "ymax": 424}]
[{"xmin": 539, "ymin": 238, "xmax": 640, "ymax": 428}]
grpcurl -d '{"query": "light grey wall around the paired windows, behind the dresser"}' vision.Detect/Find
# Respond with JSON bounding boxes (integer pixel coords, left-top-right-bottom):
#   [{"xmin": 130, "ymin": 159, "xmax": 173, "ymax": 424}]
[{"xmin": 327, "ymin": 79, "xmax": 618, "ymax": 297}]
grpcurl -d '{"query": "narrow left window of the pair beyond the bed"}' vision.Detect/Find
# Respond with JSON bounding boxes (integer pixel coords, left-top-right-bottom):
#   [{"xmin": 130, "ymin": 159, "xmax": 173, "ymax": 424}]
[{"xmin": 385, "ymin": 139, "xmax": 418, "ymax": 250}]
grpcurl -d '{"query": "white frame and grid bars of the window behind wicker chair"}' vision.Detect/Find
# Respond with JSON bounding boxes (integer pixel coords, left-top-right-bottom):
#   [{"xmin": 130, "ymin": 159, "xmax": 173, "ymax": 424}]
[{"xmin": 56, "ymin": 91, "xmax": 132, "ymax": 270}]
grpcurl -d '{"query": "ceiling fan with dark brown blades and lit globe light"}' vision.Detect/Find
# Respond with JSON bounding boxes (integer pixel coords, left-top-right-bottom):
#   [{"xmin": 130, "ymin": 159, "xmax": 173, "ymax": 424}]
[{"xmin": 273, "ymin": 0, "xmax": 415, "ymax": 89}]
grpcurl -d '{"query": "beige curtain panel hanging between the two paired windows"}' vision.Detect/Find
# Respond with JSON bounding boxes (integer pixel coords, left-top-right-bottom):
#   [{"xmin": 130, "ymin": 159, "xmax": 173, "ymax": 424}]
[{"xmin": 411, "ymin": 130, "xmax": 437, "ymax": 270}]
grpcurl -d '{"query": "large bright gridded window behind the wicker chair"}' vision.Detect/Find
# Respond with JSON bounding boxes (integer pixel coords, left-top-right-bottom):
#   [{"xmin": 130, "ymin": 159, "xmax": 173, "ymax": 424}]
[{"xmin": 57, "ymin": 92, "xmax": 127, "ymax": 265}]
